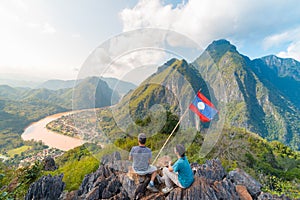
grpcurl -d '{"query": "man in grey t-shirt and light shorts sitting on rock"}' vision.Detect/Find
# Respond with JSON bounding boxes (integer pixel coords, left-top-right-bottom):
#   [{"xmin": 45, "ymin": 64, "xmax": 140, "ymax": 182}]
[{"xmin": 129, "ymin": 133, "xmax": 158, "ymax": 192}]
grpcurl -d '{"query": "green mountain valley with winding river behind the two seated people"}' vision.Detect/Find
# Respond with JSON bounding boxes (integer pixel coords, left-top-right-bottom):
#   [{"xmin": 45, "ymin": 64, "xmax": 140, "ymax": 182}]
[{"xmin": 0, "ymin": 40, "xmax": 300, "ymax": 198}]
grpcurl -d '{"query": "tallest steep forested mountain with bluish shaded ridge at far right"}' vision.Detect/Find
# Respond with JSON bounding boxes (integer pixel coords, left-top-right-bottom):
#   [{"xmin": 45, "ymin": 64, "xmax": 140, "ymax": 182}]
[{"xmin": 193, "ymin": 40, "xmax": 300, "ymax": 150}]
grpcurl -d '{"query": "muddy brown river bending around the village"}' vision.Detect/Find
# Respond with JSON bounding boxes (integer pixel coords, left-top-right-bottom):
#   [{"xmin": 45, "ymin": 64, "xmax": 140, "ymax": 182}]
[{"xmin": 21, "ymin": 112, "xmax": 84, "ymax": 151}]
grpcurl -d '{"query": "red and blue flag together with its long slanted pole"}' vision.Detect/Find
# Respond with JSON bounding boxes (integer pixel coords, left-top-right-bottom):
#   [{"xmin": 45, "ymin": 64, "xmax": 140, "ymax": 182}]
[{"xmin": 152, "ymin": 91, "xmax": 218, "ymax": 165}]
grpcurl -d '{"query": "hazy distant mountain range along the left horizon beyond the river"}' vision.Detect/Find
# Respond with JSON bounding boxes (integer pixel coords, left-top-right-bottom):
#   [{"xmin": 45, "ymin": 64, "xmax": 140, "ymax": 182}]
[{"xmin": 0, "ymin": 77, "xmax": 136, "ymax": 109}]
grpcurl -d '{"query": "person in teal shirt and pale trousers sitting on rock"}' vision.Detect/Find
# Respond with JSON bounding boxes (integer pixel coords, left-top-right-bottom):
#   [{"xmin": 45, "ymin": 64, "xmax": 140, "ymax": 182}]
[{"xmin": 161, "ymin": 144, "xmax": 194, "ymax": 194}]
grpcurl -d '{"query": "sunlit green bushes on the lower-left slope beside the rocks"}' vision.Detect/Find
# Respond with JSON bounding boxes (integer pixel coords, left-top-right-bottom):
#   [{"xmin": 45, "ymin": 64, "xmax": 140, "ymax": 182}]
[{"xmin": 0, "ymin": 144, "xmax": 122, "ymax": 199}]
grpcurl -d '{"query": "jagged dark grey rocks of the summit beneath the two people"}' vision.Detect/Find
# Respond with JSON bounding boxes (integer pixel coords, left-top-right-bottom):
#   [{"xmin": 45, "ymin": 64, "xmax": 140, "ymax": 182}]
[{"xmin": 25, "ymin": 152, "xmax": 289, "ymax": 200}]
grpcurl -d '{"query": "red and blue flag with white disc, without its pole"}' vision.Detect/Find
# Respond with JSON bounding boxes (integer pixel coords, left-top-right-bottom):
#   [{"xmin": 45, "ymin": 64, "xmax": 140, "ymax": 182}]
[{"xmin": 190, "ymin": 92, "xmax": 218, "ymax": 122}]
